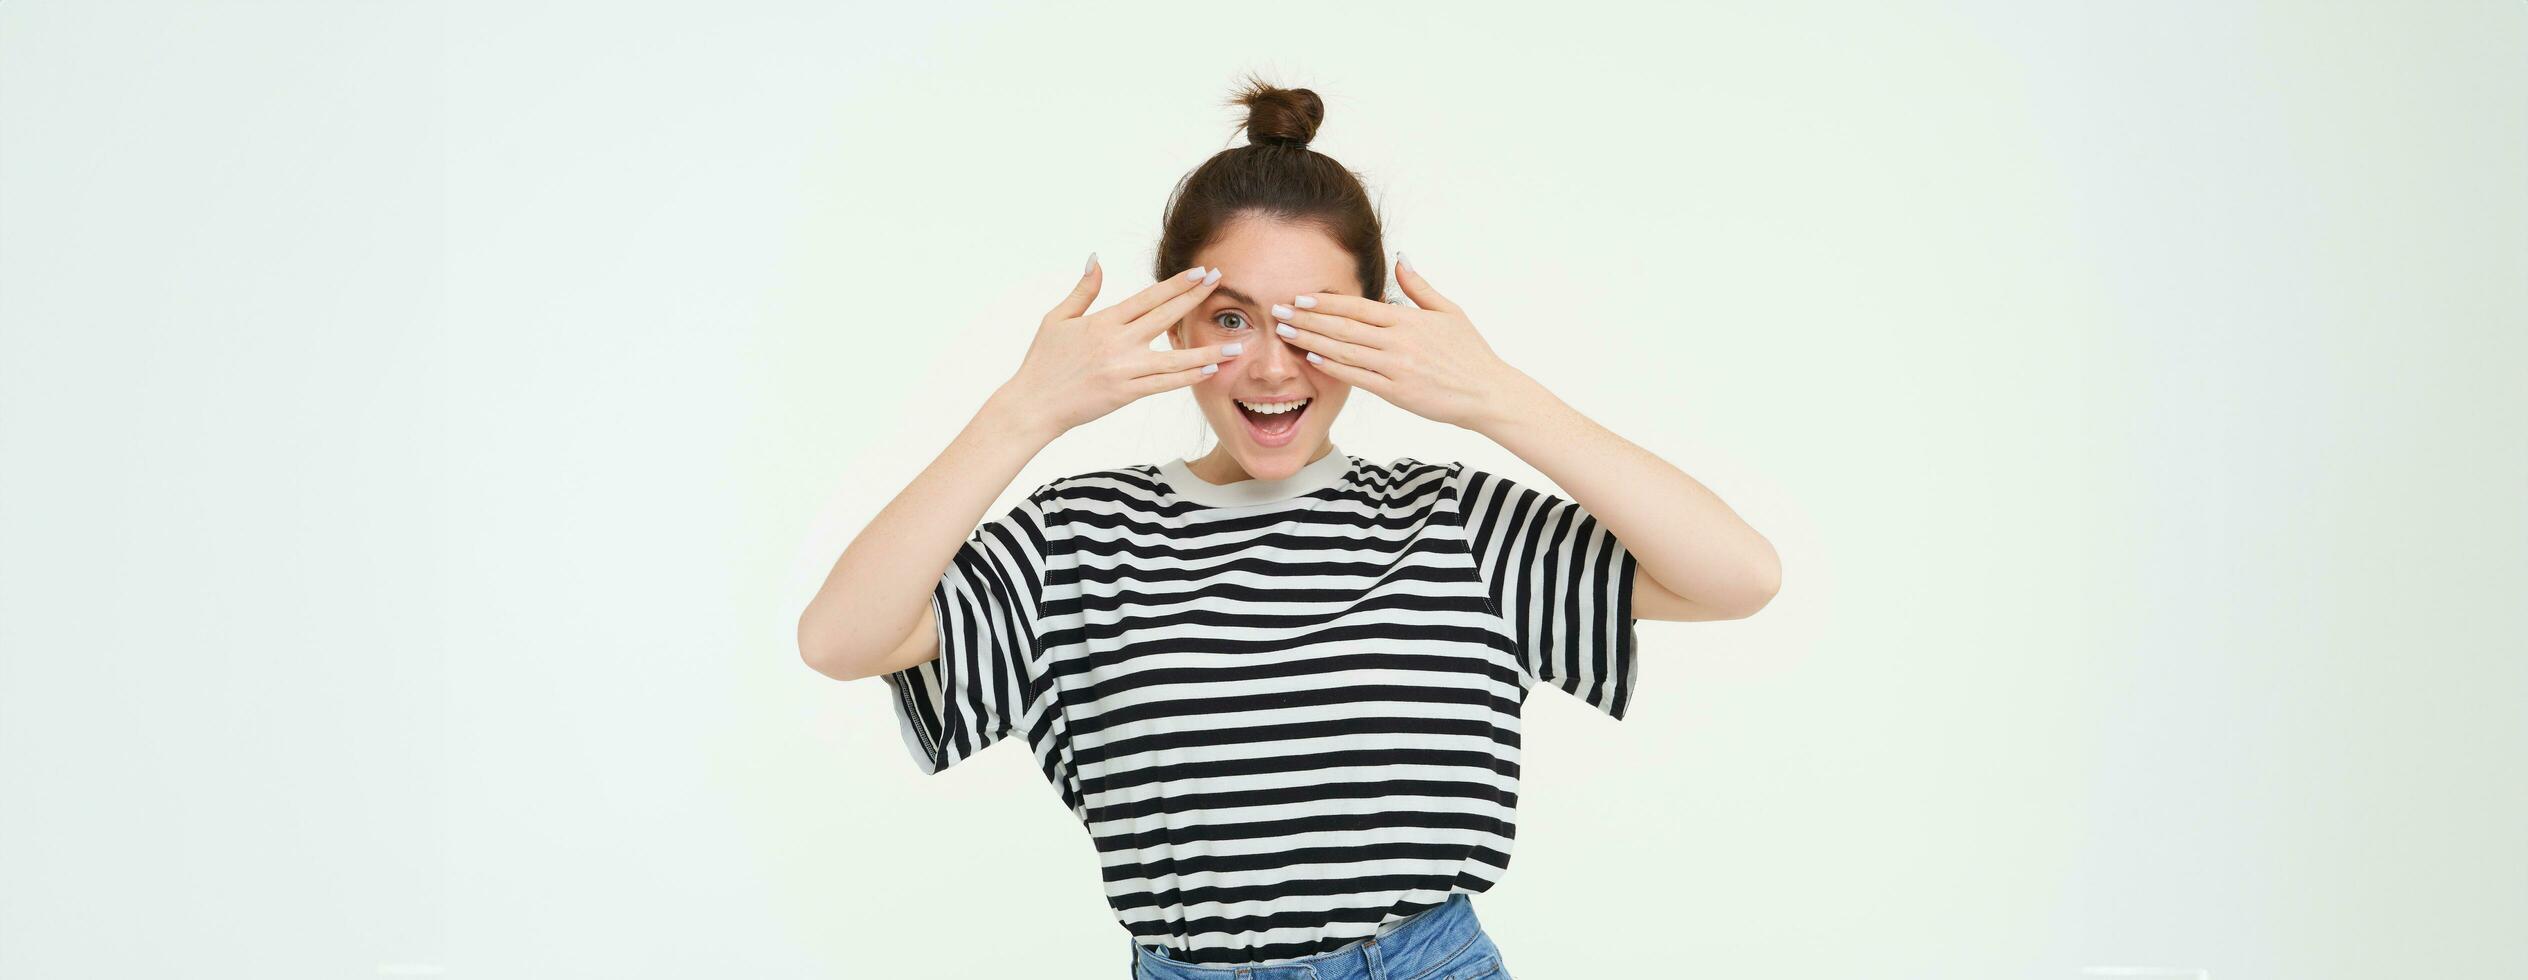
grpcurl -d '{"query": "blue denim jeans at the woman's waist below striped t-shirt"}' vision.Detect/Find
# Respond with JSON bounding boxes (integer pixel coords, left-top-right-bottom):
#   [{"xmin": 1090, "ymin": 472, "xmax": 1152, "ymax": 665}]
[{"xmin": 1133, "ymin": 892, "xmax": 1512, "ymax": 980}]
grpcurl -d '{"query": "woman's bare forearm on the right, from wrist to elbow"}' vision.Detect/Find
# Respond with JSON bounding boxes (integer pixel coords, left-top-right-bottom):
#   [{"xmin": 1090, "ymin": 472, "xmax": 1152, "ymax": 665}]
[{"xmin": 1469, "ymin": 374, "xmax": 1782, "ymax": 616}]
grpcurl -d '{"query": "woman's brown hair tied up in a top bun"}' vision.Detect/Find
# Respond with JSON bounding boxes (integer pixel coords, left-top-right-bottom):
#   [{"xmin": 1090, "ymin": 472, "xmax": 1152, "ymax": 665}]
[{"xmin": 1150, "ymin": 76, "xmax": 1388, "ymax": 301}]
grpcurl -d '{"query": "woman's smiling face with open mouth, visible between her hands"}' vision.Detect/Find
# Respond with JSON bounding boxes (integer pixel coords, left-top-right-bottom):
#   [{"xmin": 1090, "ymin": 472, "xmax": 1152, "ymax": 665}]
[{"xmin": 1168, "ymin": 217, "xmax": 1360, "ymax": 482}]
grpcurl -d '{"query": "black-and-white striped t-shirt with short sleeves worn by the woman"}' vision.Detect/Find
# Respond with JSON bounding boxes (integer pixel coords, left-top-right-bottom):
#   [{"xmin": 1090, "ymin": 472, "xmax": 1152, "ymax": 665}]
[{"xmin": 885, "ymin": 447, "xmax": 1638, "ymax": 965}]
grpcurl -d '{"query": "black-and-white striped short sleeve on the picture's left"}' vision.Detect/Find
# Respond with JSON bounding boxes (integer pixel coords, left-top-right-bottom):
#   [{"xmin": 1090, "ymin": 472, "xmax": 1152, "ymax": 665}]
[{"xmin": 885, "ymin": 485, "xmax": 1054, "ymax": 775}]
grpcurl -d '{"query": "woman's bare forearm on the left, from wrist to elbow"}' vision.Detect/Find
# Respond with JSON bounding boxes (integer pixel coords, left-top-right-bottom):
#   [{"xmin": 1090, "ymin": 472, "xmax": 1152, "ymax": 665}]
[{"xmin": 799, "ymin": 389, "xmax": 1059, "ymax": 679}]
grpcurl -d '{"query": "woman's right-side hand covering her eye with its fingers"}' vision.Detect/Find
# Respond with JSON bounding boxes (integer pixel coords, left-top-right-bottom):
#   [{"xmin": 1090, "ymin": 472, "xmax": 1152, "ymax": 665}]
[{"xmin": 1272, "ymin": 255, "xmax": 1534, "ymax": 429}]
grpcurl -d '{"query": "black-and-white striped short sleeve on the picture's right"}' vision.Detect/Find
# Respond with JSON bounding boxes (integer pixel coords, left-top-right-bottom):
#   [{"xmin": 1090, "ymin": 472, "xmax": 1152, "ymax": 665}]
[{"xmin": 1449, "ymin": 462, "xmax": 1641, "ymax": 720}]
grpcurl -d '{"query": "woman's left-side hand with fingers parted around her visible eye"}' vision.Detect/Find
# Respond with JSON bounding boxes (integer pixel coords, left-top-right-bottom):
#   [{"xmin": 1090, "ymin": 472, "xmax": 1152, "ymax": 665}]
[{"xmin": 996, "ymin": 260, "xmax": 1236, "ymax": 437}]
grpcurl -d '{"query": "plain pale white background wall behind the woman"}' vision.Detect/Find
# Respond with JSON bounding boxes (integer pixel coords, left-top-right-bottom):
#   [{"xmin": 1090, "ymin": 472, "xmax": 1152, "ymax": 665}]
[{"xmin": 0, "ymin": 0, "xmax": 2528, "ymax": 980}]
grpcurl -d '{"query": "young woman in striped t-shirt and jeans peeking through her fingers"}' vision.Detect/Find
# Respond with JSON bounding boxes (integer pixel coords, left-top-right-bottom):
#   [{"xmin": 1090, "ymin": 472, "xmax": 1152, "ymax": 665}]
[{"xmin": 799, "ymin": 83, "xmax": 1780, "ymax": 980}]
